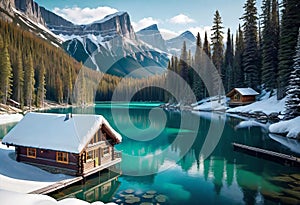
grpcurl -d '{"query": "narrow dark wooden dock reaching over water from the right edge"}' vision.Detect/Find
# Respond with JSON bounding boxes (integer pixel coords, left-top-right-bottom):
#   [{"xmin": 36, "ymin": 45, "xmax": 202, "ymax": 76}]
[{"xmin": 232, "ymin": 143, "xmax": 300, "ymax": 167}]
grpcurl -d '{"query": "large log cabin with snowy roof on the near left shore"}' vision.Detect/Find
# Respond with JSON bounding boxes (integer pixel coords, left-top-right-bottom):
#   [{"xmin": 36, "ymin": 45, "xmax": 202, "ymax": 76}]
[{"xmin": 2, "ymin": 112, "xmax": 122, "ymax": 176}]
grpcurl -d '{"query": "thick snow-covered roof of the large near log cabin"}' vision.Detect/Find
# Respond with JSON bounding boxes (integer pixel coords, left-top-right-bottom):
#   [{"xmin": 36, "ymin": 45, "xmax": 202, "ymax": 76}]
[{"xmin": 2, "ymin": 112, "xmax": 122, "ymax": 153}]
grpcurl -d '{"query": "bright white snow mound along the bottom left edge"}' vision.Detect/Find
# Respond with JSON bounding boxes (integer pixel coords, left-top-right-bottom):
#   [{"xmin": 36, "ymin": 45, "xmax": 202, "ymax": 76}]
[{"xmin": 0, "ymin": 189, "xmax": 115, "ymax": 205}]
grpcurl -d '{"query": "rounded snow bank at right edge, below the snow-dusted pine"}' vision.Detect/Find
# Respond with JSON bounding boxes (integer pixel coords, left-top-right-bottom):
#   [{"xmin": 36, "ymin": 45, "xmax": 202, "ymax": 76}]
[{"xmin": 269, "ymin": 117, "xmax": 300, "ymax": 138}]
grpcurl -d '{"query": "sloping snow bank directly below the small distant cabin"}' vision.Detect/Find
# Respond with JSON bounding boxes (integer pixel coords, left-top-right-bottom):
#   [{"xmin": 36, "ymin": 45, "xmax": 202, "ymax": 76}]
[{"xmin": 227, "ymin": 96, "xmax": 286, "ymax": 115}]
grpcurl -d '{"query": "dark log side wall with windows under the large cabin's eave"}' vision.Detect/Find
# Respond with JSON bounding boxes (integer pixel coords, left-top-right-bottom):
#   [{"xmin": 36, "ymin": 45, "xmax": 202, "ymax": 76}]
[{"xmin": 16, "ymin": 147, "xmax": 79, "ymax": 175}]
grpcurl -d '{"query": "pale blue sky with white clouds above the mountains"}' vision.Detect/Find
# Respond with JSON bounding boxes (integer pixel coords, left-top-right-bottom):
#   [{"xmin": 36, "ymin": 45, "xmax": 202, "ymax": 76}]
[{"xmin": 35, "ymin": 0, "xmax": 261, "ymax": 39}]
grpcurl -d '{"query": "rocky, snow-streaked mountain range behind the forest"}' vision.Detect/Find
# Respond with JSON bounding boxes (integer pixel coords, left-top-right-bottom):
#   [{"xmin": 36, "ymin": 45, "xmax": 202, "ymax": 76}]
[{"xmin": 0, "ymin": 0, "xmax": 196, "ymax": 78}]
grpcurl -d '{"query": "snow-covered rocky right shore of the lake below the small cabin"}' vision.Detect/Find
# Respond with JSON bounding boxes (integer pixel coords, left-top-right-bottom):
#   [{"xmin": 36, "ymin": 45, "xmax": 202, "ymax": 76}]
[{"xmin": 191, "ymin": 93, "xmax": 300, "ymax": 139}]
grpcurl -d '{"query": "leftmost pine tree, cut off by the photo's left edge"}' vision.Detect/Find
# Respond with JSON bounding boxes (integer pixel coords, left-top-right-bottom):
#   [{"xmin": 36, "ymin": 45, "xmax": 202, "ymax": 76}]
[{"xmin": 0, "ymin": 35, "xmax": 12, "ymax": 104}]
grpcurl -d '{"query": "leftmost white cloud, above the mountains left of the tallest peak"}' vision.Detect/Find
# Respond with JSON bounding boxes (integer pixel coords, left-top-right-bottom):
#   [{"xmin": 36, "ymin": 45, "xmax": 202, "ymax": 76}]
[{"xmin": 53, "ymin": 6, "xmax": 118, "ymax": 24}]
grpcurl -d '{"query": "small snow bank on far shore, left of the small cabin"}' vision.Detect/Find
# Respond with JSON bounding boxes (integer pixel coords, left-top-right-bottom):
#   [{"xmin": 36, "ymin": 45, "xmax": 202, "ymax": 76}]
[{"xmin": 192, "ymin": 96, "xmax": 227, "ymax": 111}]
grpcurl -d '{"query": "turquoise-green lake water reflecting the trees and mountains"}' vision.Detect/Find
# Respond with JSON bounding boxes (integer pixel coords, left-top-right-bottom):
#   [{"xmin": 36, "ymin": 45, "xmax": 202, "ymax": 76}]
[{"xmin": 0, "ymin": 103, "xmax": 300, "ymax": 205}]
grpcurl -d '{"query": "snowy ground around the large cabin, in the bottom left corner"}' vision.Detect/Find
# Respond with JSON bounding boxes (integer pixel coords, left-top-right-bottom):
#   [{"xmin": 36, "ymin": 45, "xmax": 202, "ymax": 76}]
[{"xmin": 0, "ymin": 142, "xmax": 114, "ymax": 205}]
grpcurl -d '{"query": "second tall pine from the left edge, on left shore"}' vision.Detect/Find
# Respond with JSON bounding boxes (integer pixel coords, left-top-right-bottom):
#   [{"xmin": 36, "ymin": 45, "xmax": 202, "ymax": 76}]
[{"xmin": 13, "ymin": 50, "xmax": 24, "ymax": 108}]
